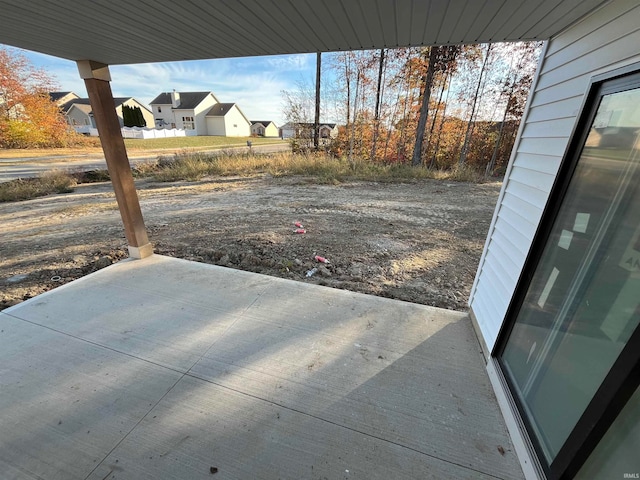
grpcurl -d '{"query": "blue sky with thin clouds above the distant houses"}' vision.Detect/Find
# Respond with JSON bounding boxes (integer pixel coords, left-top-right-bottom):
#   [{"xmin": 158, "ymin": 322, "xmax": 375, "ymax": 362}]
[{"xmin": 8, "ymin": 47, "xmax": 316, "ymax": 125}]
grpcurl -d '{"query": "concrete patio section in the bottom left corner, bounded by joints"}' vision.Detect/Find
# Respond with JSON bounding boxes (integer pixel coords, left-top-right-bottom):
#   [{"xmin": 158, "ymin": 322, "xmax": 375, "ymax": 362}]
[{"xmin": 0, "ymin": 312, "xmax": 181, "ymax": 480}]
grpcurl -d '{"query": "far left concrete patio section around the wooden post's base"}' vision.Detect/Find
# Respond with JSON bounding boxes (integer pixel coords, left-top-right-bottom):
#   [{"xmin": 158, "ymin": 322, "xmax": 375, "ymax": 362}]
[{"xmin": 5, "ymin": 256, "xmax": 270, "ymax": 372}]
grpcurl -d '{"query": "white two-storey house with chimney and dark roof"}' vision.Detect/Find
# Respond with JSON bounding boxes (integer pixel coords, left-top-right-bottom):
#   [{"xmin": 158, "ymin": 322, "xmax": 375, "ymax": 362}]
[{"xmin": 150, "ymin": 90, "xmax": 220, "ymax": 135}]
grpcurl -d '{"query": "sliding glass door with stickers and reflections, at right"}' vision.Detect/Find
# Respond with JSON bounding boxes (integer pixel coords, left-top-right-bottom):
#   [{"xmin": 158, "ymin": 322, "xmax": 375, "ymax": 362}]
[{"xmin": 498, "ymin": 70, "xmax": 640, "ymax": 478}]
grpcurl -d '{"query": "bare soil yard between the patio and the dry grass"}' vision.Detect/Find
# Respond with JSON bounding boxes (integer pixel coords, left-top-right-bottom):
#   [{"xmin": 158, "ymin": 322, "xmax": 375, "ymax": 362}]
[{"xmin": 0, "ymin": 177, "xmax": 500, "ymax": 310}]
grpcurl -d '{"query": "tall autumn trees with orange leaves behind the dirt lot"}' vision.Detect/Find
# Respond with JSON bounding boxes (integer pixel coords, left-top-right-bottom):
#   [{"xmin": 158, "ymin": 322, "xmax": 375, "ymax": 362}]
[{"xmin": 282, "ymin": 42, "xmax": 541, "ymax": 175}]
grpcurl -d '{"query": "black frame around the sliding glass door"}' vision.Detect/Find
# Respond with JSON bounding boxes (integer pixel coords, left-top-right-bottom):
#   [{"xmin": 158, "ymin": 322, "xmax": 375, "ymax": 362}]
[{"xmin": 491, "ymin": 63, "xmax": 640, "ymax": 480}]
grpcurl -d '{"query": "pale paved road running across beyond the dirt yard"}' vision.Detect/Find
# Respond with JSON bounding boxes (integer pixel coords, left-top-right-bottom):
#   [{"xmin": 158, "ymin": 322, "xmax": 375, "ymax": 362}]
[{"xmin": 0, "ymin": 143, "xmax": 290, "ymax": 182}]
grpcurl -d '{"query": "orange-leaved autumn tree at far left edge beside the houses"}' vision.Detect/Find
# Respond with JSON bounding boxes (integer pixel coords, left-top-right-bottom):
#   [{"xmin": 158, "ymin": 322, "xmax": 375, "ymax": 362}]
[{"xmin": 0, "ymin": 48, "xmax": 79, "ymax": 148}]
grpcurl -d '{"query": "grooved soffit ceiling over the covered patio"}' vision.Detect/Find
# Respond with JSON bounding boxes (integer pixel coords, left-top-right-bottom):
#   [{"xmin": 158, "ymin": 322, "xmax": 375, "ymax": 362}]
[{"xmin": 0, "ymin": 0, "xmax": 606, "ymax": 64}]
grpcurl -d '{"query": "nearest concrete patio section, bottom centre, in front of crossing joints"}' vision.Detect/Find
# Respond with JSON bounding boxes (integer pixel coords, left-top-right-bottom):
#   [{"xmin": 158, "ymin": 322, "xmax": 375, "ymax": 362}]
[{"xmin": 89, "ymin": 377, "xmax": 504, "ymax": 480}]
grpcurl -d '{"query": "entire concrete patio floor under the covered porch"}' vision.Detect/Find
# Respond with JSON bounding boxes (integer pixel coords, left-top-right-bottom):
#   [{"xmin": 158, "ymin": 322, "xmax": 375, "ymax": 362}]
[{"xmin": 0, "ymin": 255, "xmax": 522, "ymax": 480}]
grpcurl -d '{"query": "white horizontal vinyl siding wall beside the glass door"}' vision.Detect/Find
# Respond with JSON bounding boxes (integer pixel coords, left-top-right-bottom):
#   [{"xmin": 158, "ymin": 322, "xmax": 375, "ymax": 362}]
[{"xmin": 469, "ymin": 0, "xmax": 640, "ymax": 350}]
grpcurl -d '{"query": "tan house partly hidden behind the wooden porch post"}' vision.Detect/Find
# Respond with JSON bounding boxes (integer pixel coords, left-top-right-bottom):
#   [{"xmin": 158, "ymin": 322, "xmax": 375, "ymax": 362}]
[{"xmin": 49, "ymin": 92, "xmax": 153, "ymax": 130}]
